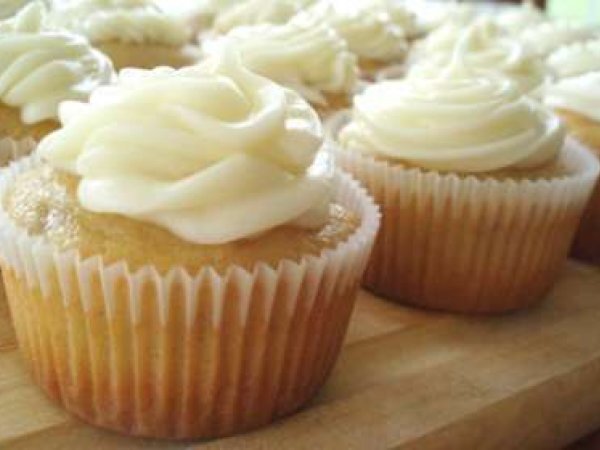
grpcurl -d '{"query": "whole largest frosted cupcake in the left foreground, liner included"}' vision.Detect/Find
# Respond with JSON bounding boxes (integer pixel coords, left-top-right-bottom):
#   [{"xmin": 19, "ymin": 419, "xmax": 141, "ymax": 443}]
[{"xmin": 0, "ymin": 47, "xmax": 379, "ymax": 439}]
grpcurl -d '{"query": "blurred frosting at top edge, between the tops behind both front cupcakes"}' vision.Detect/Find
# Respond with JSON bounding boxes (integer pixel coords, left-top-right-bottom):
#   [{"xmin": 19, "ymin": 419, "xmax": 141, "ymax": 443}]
[{"xmin": 306, "ymin": 0, "xmax": 408, "ymax": 62}]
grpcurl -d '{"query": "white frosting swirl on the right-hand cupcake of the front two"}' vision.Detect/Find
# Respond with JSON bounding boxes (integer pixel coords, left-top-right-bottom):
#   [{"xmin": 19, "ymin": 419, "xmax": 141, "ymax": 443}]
[{"xmin": 339, "ymin": 67, "xmax": 564, "ymax": 173}]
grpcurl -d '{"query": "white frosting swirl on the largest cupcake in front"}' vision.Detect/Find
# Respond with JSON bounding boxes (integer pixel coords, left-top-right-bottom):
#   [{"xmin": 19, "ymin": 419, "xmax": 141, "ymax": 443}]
[{"xmin": 39, "ymin": 52, "xmax": 329, "ymax": 244}]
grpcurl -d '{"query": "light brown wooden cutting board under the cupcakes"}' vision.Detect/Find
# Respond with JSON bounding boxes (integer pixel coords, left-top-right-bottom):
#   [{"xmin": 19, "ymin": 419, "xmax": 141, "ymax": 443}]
[{"xmin": 0, "ymin": 263, "xmax": 600, "ymax": 450}]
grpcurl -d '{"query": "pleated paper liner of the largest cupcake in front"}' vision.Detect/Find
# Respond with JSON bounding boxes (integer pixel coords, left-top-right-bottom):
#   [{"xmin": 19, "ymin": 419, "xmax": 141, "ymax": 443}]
[{"xmin": 0, "ymin": 158, "xmax": 379, "ymax": 439}]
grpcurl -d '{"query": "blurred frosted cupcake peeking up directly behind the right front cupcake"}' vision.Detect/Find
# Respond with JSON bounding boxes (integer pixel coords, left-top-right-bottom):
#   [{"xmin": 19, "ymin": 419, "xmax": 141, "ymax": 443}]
[{"xmin": 408, "ymin": 19, "xmax": 548, "ymax": 94}]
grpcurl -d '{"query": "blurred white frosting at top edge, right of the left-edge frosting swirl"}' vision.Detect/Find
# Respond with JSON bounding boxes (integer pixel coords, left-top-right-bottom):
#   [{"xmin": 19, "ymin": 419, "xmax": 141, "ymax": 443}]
[{"xmin": 50, "ymin": 0, "xmax": 188, "ymax": 47}]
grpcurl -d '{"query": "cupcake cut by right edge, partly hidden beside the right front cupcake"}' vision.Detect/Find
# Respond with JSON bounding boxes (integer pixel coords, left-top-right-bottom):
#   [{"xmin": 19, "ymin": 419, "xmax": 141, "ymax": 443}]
[{"xmin": 545, "ymin": 71, "xmax": 600, "ymax": 265}]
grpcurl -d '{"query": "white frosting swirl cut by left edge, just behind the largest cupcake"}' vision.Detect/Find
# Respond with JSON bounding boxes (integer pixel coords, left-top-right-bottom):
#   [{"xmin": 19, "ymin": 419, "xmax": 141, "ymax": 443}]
[{"xmin": 0, "ymin": 3, "xmax": 113, "ymax": 124}]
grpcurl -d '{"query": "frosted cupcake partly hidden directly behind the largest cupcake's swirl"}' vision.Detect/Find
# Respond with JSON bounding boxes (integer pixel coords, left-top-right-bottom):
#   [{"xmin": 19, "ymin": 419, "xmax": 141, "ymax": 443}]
[{"xmin": 204, "ymin": 15, "xmax": 358, "ymax": 116}]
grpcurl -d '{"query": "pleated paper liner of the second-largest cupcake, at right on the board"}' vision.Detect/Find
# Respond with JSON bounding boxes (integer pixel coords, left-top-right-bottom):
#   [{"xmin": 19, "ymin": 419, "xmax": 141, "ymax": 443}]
[{"xmin": 327, "ymin": 110, "xmax": 599, "ymax": 313}]
